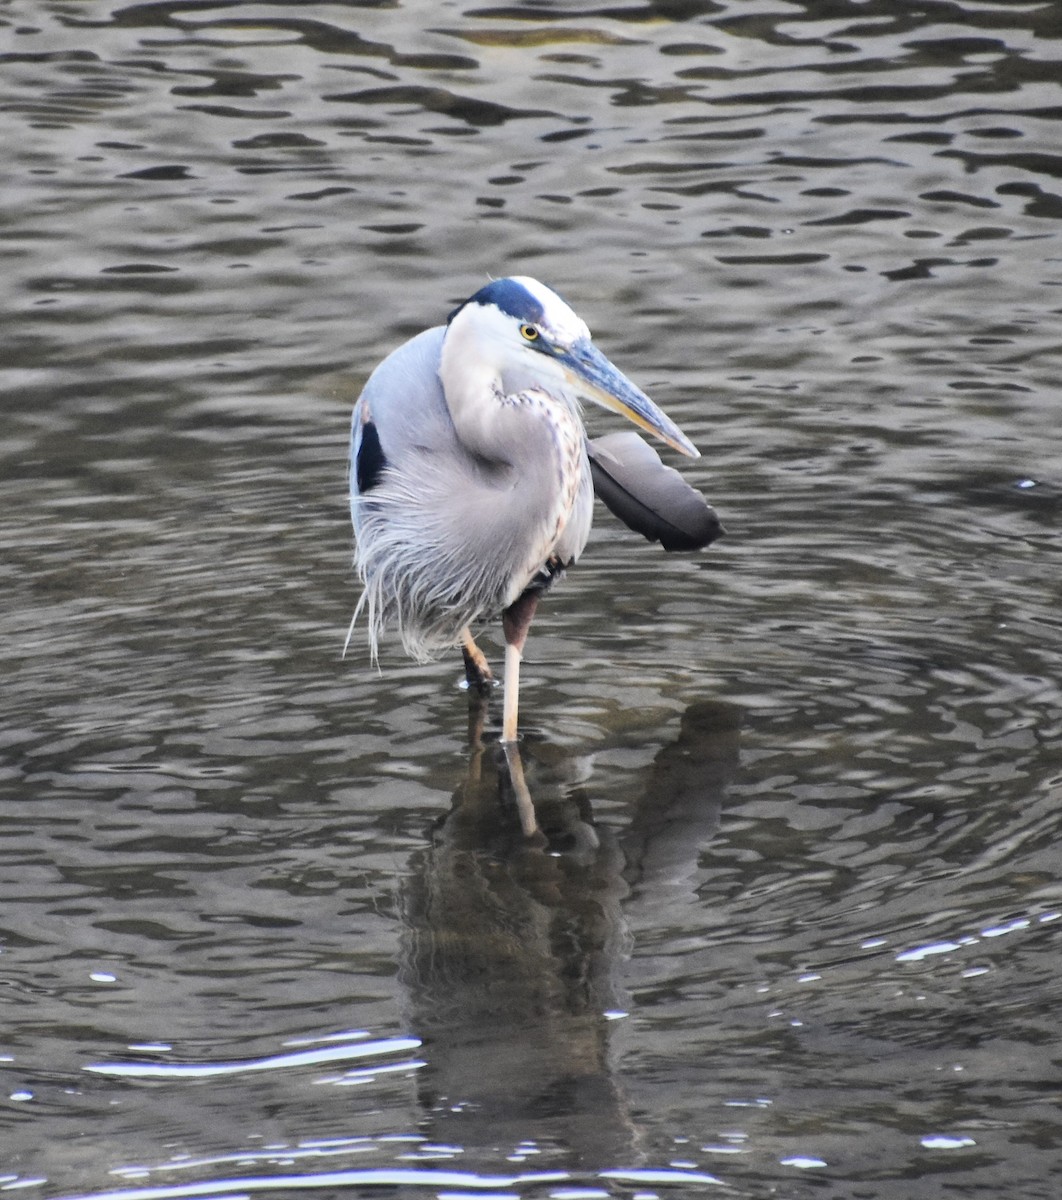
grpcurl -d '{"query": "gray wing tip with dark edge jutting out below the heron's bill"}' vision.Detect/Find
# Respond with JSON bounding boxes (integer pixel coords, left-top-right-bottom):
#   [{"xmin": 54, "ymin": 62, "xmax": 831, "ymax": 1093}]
[{"xmin": 588, "ymin": 431, "xmax": 726, "ymax": 550}]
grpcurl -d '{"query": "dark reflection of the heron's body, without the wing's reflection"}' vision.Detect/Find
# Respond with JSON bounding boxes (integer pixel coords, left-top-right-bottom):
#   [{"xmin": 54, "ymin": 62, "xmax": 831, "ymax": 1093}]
[{"xmin": 402, "ymin": 748, "xmax": 632, "ymax": 1165}]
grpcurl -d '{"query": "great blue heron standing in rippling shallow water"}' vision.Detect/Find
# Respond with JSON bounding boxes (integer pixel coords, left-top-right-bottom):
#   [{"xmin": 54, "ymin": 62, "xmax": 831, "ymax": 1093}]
[{"xmin": 348, "ymin": 276, "xmax": 720, "ymax": 744}]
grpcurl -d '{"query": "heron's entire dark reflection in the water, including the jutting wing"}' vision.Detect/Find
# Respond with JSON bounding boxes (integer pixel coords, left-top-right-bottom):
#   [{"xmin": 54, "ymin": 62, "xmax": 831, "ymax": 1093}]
[{"xmin": 401, "ymin": 704, "xmax": 739, "ymax": 1168}]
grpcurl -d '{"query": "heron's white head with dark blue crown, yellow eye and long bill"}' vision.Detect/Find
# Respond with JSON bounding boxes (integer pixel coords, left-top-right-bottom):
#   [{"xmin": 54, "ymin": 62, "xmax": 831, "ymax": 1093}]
[{"xmin": 448, "ymin": 275, "xmax": 698, "ymax": 458}]
